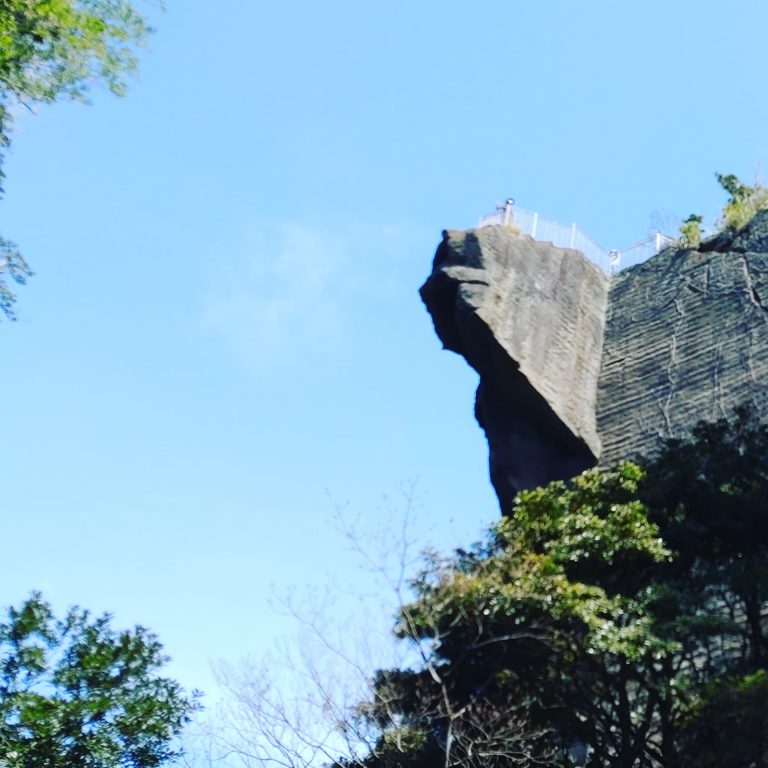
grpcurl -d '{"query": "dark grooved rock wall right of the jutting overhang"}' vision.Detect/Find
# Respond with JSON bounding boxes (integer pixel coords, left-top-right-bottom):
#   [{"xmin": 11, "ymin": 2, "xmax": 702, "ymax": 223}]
[{"xmin": 597, "ymin": 212, "xmax": 768, "ymax": 465}]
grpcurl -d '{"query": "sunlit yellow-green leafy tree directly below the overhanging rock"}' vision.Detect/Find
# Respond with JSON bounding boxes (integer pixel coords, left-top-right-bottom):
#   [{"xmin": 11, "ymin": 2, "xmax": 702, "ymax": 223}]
[{"xmin": 352, "ymin": 464, "xmax": 670, "ymax": 768}]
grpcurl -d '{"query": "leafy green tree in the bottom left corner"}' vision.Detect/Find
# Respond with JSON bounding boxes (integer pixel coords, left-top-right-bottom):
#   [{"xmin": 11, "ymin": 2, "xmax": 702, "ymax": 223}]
[{"xmin": 0, "ymin": 593, "xmax": 197, "ymax": 768}]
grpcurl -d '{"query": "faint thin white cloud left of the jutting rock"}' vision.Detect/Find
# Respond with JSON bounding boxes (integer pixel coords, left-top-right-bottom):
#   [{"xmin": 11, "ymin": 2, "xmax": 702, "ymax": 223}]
[{"xmin": 203, "ymin": 223, "xmax": 424, "ymax": 370}]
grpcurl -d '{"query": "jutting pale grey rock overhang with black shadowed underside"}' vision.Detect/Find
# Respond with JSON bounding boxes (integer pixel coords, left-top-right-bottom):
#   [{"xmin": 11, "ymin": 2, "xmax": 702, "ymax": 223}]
[{"xmin": 421, "ymin": 226, "xmax": 608, "ymax": 509}]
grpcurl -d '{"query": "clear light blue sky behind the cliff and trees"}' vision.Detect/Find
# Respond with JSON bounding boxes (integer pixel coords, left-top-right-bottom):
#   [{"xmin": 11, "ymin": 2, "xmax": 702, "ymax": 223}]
[{"xmin": 0, "ymin": 0, "xmax": 768, "ymax": 704}]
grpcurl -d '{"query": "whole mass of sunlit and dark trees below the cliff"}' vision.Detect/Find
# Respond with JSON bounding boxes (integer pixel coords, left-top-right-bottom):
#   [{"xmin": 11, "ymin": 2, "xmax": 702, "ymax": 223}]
[{"xmin": 356, "ymin": 410, "xmax": 768, "ymax": 768}]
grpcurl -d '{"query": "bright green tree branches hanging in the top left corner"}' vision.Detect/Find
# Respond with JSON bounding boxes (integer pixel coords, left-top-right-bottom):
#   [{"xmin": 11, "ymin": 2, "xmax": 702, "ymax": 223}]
[{"xmin": 0, "ymin": 0, "xmax": 150, "ymax": 319}]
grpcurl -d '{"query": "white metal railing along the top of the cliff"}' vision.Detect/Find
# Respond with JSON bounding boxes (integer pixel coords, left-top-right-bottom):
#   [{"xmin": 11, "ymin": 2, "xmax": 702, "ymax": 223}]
[{"xmin": 478, "ymin": 200, "xmax": 675, "ymax": 274}]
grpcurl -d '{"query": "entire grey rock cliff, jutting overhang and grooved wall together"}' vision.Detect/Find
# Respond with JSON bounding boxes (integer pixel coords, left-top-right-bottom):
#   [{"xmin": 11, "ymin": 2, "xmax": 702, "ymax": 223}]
[{"xmin": 421, "ymin": 211, "xmax": 768, "ymax": 511}]
